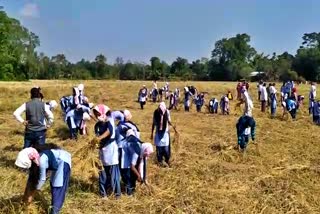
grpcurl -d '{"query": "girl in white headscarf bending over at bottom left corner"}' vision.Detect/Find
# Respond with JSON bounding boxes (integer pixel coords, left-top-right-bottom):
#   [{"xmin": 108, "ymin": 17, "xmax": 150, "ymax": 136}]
[{"xmin": 15, "ymin": 144, "xmax": 71, "ymax": 214}]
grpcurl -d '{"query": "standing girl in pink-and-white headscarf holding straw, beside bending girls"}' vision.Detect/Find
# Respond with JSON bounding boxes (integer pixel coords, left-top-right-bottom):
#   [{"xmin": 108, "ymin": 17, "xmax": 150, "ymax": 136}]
[{"xmin": 93, "ymin": 104, "xmax": 121, "ymax": 198}]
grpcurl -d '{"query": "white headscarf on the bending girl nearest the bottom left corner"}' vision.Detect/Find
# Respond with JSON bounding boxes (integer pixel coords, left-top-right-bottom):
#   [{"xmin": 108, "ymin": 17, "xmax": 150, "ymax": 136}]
[{"xmin": 15, "ymin": 147, "xmax": 40, "ymax": 169}]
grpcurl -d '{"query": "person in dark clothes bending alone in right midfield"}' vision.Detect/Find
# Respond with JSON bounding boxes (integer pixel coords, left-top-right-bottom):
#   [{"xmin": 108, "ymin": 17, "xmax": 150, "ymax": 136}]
[{"xmin": 236, "ymin": 115, "xmax": 256, "ymax": 152}]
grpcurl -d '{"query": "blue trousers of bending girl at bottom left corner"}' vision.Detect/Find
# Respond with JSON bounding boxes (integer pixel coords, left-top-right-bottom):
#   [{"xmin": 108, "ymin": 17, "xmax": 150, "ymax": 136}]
[{"xmin": 51, "ymin": 163, "xmax": 71, "ymax": 214}]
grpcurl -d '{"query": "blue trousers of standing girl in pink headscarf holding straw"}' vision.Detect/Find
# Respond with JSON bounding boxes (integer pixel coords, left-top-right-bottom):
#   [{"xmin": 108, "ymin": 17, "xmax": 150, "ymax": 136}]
[{"xmin": 99, "ymin": 164, "xmax": 121, "ymax": 197}]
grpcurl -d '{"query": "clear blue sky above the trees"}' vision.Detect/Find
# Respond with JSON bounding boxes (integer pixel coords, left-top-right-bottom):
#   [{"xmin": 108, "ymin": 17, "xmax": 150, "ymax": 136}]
[{"xmin": 0, "ymin": 0, "xmax": 320, "ymax": 63}]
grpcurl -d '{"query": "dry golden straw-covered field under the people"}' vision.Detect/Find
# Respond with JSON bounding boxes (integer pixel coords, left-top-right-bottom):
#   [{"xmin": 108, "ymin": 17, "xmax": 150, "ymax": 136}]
[{"xmin": 0, "ymin": 81, "xmax": 320, "ymax": 214}]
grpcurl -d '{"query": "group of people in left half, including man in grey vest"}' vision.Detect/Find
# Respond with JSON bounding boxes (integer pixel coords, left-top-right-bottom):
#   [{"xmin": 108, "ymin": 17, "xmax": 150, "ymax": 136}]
[{"xmin": 14, "ymin": 87, "xmax": 176, "ymax": 213}]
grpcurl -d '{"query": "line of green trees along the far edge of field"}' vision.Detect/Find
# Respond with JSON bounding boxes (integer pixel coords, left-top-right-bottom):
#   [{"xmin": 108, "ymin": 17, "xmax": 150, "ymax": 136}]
[{"xmin": 0, "ymin": 8, "xmax": 320, "ymax": 81}]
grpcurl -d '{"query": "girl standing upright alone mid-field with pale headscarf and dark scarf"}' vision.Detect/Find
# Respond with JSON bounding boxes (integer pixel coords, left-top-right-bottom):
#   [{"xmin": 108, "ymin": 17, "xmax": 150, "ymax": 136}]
[{"xmin": 151, "ymin": 102, "xmax": 176, "ymax": 166}]
